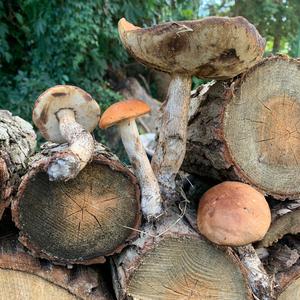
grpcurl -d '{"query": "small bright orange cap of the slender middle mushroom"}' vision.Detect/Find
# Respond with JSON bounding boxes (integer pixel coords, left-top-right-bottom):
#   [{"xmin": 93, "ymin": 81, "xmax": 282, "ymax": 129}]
[{"xmin": 99, "ymin": 99, "xmax": 151, "ymax": 129}]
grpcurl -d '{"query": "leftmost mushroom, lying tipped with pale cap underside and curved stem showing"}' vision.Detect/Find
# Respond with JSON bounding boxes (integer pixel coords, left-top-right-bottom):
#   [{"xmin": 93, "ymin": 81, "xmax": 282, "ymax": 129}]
[{"xmin": 32, "ymin": 85, "xmax": 100, "ymax": 181}]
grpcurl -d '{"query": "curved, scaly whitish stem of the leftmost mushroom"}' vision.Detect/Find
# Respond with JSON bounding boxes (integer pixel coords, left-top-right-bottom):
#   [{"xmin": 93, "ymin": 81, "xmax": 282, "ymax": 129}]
[{"xmin": 48, "ymin": 109, "xmax": 94, "ymax": 181}]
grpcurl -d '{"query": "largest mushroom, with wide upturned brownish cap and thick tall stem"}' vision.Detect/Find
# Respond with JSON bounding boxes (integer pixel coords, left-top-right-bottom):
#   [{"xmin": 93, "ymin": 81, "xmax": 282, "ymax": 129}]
[{"xmin": 118, "ymin": 17, "xmax": 265, "ymax": 191}]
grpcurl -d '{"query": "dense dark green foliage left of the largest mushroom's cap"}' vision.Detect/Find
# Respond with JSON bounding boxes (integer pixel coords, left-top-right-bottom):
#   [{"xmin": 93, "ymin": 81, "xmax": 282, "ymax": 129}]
[{"xmin": 0, "ymin": 0, "xmax": 197, "ymax": 124}]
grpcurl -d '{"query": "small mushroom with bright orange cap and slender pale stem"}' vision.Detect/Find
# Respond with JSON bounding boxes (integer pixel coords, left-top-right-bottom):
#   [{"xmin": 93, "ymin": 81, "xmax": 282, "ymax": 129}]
[{"xmin": 99, "ymin": 99, "xmax": 162, "ymax": 219}]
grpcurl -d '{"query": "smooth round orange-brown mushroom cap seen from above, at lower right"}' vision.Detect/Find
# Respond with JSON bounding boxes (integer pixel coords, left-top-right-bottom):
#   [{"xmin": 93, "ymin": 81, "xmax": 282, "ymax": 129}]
[{"xmin": 197, "ymin": 181, "xmax": 271, "ymax": 246}]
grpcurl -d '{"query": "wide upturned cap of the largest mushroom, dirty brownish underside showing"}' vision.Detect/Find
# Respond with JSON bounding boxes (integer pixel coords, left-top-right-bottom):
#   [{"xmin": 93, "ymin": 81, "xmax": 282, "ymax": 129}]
[{"xmin": 118, "ymin": 17, "xmax": 265, "ymax": 79}]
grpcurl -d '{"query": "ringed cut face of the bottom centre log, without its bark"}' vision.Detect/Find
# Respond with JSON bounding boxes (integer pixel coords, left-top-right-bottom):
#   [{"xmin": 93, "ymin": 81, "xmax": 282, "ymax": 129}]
[{"xmin": 127, "ymin": 237, "xmax": 250, "ymax": 300}]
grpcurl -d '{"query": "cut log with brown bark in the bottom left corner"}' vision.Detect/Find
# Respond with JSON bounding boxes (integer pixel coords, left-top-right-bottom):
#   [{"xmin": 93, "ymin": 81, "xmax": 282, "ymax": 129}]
[{"xmin": 0, "ymin": 239, "xmax": 113, "ymax": 300}]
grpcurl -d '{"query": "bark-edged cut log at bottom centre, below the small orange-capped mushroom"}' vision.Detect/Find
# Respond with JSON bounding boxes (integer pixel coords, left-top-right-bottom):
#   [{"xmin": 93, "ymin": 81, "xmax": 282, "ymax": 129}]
[{"xmin": 112, "ymin": 211, "xmax": 252, "ymax": 300}]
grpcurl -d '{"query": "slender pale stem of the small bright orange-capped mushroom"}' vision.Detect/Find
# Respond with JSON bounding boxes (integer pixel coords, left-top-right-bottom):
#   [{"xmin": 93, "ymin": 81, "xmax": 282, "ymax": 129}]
[{"xmin": 118, "ymin": 119, "xmax": 162, "ymax": 219}]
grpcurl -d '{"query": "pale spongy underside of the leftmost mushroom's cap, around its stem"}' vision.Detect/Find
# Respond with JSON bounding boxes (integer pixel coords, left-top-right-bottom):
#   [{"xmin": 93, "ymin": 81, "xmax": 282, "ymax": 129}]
[{"xmin": 32, "ymin": 85, "xmax": 100, "ymax": 143}]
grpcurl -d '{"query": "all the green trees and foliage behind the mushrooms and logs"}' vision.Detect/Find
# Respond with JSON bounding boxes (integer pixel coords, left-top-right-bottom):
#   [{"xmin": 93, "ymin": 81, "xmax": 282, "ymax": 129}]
[{"xmin": 0, "ymin": 0, "xmax": 300, "ymax": 129}]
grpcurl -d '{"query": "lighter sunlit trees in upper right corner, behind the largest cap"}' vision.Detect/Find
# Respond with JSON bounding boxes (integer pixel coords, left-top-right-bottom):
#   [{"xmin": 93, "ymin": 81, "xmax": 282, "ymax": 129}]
[{"xmin": 206, "ymin": 0, "xmax": 300, "ymax": 54}]
